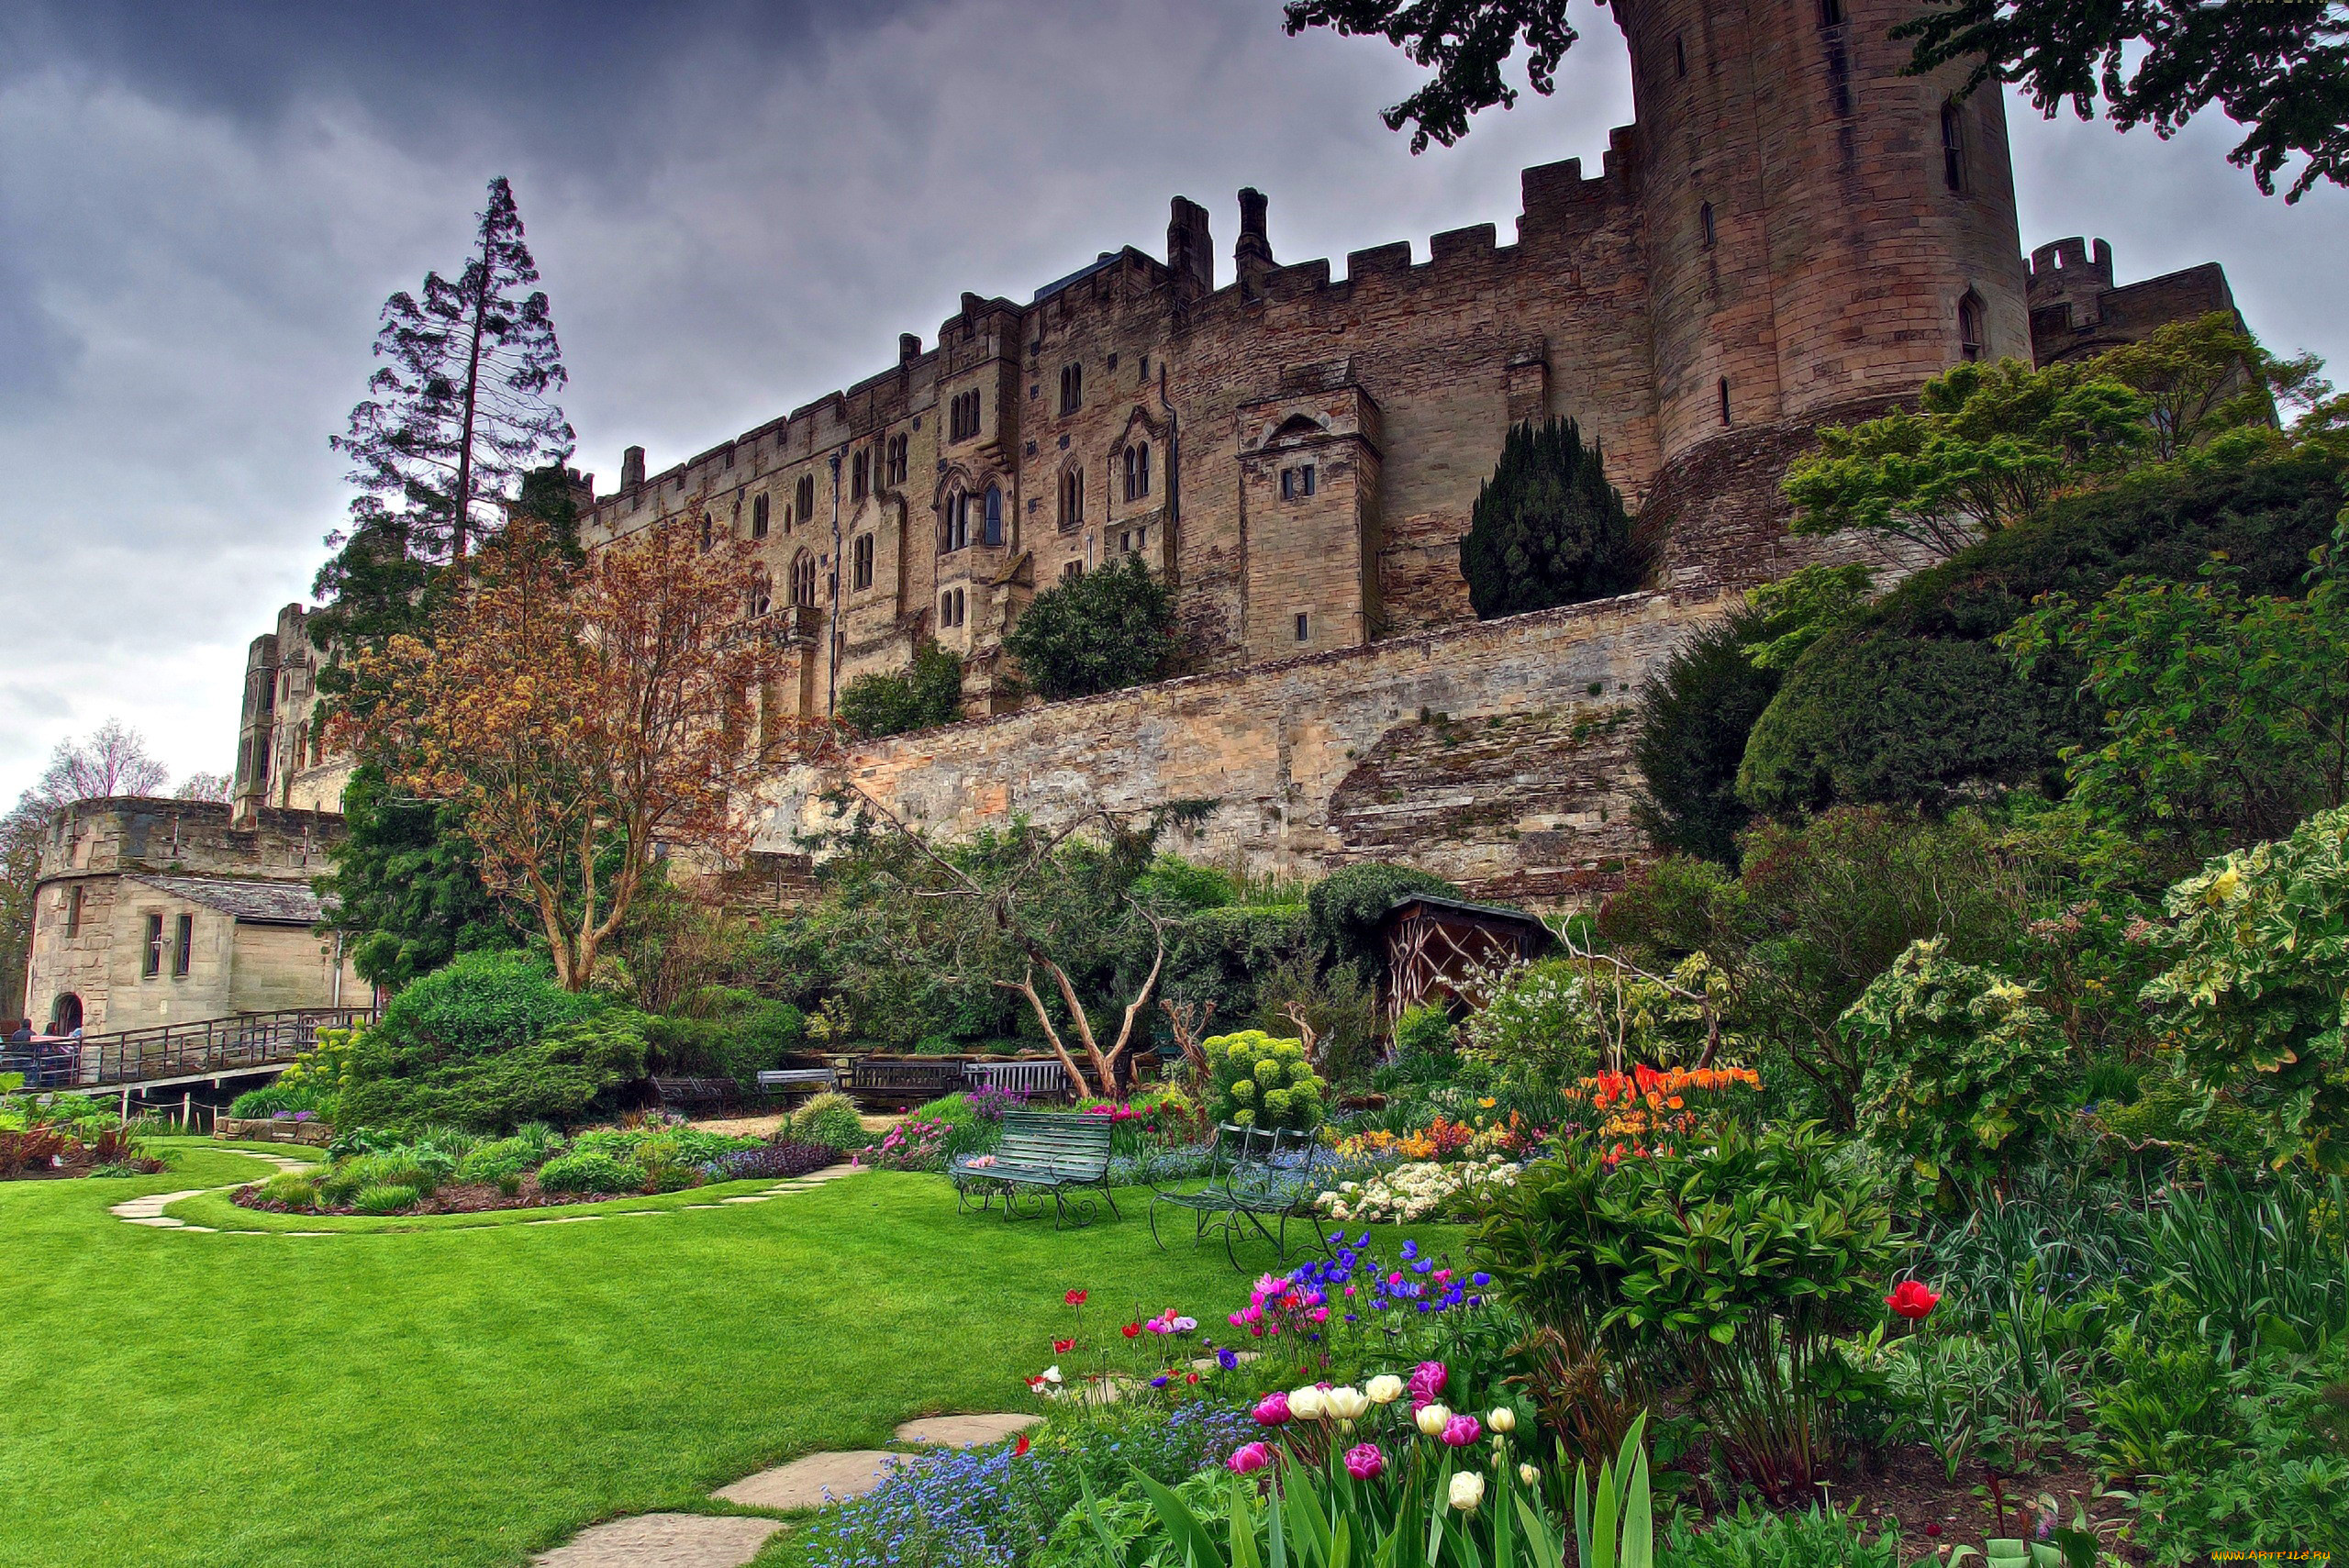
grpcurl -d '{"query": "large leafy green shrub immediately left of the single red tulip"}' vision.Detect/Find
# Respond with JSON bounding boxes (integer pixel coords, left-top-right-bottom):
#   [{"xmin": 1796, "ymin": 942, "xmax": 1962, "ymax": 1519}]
[{"xmin": 1473, "ymin": 1122, "xmax": 1896, "ymax": 1502}]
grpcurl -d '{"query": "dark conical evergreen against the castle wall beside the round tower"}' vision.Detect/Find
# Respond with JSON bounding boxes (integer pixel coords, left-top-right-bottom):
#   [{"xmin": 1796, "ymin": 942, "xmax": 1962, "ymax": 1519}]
[{"xmin": 1461, "ymin": 420, "xmax": 1649, "ymax": 619}]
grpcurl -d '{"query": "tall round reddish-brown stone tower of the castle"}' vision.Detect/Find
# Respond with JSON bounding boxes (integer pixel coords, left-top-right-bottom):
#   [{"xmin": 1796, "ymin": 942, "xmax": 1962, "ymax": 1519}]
[{"xmin": 1614, "ymin": 0, "xmax": 2032, "ymax": 582}]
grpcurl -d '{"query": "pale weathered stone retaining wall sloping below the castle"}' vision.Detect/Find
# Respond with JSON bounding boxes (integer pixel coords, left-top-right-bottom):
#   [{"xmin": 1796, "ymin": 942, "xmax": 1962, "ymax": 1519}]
[{"xmin": 759, "ymin": 594, "xmax": 1720, "ymax": 906}]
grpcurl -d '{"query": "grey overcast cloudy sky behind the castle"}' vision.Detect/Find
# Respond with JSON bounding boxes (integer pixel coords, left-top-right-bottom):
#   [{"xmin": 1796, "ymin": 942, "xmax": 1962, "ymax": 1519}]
[{"xmin": 0, "ymin": 0, "xmax": 2349, "ymax": 803}]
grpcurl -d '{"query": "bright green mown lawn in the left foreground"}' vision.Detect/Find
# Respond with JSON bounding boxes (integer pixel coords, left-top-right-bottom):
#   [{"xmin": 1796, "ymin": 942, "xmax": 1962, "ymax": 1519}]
[{"xmin": 0, "ymin": 1140, "xmax": 1324, "ymax": 1568}]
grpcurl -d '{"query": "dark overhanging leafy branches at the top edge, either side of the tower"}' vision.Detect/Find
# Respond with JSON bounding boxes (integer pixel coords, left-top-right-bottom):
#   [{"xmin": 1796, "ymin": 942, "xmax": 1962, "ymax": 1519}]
[{"xmin": 1283, "ymin": 0, "xmax": 2349, "ymax": 199}]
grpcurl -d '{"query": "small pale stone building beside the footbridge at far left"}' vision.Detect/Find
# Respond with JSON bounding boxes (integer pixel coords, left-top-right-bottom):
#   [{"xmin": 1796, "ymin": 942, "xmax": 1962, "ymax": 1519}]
[{"xmin": 24, "ymin": 798, "xmax": 369, "ymax": 1035}]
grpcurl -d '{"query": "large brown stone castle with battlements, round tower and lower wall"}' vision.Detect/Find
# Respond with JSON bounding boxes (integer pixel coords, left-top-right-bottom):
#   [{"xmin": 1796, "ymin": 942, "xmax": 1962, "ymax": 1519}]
[{"xmin": 206, "ymin": 0, "xmax": 2232, "ymax": 925}]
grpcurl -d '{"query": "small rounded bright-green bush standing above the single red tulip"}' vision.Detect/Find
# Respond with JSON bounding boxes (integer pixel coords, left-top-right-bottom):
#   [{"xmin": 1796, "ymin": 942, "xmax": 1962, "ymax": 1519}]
[{"xmin": 1842, "ymin": 937, "xmax": 2076, "ymax": 1183}]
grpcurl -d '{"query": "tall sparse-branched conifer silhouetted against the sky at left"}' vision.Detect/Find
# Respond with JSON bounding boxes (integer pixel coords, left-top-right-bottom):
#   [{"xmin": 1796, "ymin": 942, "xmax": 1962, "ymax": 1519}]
[{"xmin": 317, "ymin": 176, "xmax": 571, "ymax": 640}]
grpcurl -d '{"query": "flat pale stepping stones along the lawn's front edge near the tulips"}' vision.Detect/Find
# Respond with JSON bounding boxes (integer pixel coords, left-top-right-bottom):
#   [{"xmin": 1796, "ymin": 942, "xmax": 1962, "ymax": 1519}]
[{"xmin": 533, "ymin": 1408, "xmax": 1043, "ymax": 1568}]
